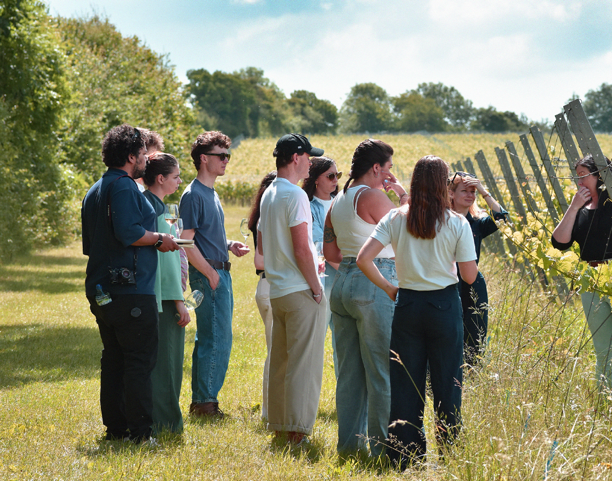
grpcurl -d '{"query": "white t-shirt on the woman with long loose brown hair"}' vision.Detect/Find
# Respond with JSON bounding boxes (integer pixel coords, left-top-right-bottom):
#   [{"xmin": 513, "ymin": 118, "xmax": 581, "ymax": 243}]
[{"xmin": 370, "ymin": 207, "xmax": 476, "ymax": 291}]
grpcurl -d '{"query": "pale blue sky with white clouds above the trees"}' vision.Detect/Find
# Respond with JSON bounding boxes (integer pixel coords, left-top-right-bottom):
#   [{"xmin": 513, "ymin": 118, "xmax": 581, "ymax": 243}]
[{"xmin": 44, "ymin": 0, "xmax": 612, "ymax": 120}]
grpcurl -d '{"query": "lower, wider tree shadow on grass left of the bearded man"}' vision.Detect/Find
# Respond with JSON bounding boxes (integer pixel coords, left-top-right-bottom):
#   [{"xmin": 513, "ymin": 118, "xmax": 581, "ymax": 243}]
[{"xmin": 0, "ymin": 324, "xmax": 102, "ymax": 387}]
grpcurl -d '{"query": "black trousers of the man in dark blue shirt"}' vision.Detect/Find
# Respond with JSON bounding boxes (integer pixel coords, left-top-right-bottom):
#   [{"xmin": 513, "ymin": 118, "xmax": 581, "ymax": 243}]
[{"xmin": 88, "ymin": 294, "xmax": 158, "ymax": 441}]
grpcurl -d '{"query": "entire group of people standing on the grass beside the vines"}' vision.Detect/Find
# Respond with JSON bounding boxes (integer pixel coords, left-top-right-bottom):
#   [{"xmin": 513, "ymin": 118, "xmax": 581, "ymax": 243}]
[{"xmin": 82, "ymin": 125, "xmax": 612, "ymax": 467}]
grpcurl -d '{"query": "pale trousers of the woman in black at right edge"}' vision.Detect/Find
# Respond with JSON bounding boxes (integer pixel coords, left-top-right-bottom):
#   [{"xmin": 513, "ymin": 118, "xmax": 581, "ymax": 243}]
[{"xmin": 580, "ymin": 292, "xmax": 612, "ymax": 389}]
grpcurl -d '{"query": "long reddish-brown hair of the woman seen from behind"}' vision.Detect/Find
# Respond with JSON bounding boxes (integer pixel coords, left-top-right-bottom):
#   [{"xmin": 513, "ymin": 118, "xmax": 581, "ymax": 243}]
[{"xmin": 406, "ymin": 155, "xmax": 450, "ymax": 239}]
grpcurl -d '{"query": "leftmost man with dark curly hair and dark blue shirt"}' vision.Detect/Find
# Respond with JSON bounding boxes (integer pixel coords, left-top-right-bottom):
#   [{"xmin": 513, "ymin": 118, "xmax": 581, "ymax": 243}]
[{"xmin": 81, "ymin": 124, "xmax": 178, "ymax": 442}]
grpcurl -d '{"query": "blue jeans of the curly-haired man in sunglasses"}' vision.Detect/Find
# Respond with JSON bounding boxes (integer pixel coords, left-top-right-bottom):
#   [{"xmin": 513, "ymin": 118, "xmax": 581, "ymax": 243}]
[{"xmin": 189, "ymin": 266, "xmax": 234, "ymax": 403}]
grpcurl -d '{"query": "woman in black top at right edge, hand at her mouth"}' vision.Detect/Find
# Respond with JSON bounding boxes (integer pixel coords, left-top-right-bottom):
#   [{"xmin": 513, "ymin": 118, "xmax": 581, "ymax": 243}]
[{"xmin": 551, "ymin": 154, "xmax": 612, "ymax": 389}]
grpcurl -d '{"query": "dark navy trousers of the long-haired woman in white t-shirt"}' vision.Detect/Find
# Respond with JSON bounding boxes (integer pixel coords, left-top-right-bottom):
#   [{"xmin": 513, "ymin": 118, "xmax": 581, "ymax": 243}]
[{"xmin": 388, "ymin": 284, "xmax": 463, "ymax": 467}]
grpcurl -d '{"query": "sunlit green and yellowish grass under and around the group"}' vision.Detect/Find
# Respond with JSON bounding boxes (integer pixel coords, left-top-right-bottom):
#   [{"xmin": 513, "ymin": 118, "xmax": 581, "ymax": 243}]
[{"xmin": 0, "ymin": 207, "xmax": 612, "ymax": 480}]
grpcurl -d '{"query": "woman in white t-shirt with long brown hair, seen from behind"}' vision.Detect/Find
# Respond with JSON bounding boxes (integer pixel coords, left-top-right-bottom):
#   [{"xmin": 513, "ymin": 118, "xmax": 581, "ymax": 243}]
[{"xmin": 357, "ymin": 155, "xmax": 478, "ymax": 469}]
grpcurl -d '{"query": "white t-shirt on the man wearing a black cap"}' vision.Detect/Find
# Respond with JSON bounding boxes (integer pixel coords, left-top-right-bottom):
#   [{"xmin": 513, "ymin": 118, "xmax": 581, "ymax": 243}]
[{"xmin": 257, "ymin": 177, "xmax": 318, "ymax": 299}]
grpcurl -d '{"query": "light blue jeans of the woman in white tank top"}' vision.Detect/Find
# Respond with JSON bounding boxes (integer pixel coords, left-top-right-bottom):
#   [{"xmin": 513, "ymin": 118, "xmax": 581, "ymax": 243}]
[{"xmin": 330, "ymin": 257, "xmax": 397, "ymax": 456}]
